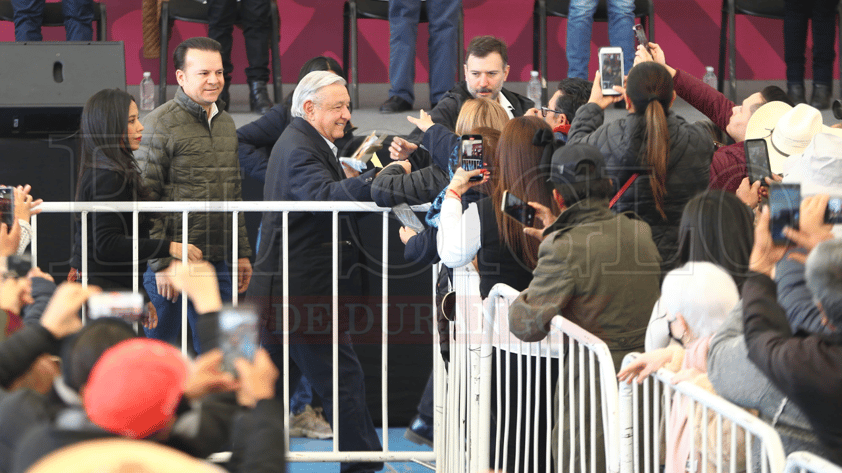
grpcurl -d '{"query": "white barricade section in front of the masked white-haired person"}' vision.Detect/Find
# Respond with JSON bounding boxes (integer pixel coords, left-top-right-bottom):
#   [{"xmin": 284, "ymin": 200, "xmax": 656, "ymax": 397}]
[{"xmin": 620, "ymin": 353, "xmax": 784, "ymax": 473}]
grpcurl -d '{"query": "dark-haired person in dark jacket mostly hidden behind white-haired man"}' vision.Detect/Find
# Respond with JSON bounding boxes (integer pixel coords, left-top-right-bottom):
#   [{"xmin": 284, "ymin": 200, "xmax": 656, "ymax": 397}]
[{"xmin": 237, "ymin": 56, "xmax": 354, "ymax": 183}]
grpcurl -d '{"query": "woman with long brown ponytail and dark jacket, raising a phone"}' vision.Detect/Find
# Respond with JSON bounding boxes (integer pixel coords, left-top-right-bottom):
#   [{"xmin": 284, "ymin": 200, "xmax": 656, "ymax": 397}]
[{"xmin": 568, "ymin": 62, "xmax": 713, "ymax": 273}]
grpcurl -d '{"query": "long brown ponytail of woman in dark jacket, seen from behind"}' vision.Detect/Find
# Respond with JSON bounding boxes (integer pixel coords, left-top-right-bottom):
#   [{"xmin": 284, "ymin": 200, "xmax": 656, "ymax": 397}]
[{"xmin": 626, "ymin": 61, "xmax": 674, "ymax": 220}]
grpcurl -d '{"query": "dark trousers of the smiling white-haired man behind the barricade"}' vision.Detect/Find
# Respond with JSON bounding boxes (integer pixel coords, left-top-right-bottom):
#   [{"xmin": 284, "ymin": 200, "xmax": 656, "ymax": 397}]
[{"xmin": 261, "ymin": 297, "xmax": 383, "ymax": 473}]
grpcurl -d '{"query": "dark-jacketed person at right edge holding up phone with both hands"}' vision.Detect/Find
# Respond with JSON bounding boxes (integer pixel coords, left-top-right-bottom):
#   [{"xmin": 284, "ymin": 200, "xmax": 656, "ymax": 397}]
[{"xmin": 743, "ymin": 195, "xmax": 842, "ymax": 464}]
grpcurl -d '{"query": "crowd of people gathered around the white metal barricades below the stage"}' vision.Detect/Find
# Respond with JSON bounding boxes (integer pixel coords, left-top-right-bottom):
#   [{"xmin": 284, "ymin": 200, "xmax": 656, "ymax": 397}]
[{"xmin": 0, "ymin": 28, "xmax": 842, "ymax": 472}]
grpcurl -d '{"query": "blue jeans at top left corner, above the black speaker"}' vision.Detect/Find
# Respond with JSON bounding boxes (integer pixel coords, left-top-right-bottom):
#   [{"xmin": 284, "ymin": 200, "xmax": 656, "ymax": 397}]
[{"xmin": 12, "ymin": 0, "xmax": 92, "ymax": 41}]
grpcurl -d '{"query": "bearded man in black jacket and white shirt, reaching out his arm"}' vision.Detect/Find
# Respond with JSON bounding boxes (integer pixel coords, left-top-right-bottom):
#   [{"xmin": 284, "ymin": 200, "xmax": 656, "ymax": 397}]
[{"xmin": 389, "ymin": 36, "xmax": 535, "ymax": 168}]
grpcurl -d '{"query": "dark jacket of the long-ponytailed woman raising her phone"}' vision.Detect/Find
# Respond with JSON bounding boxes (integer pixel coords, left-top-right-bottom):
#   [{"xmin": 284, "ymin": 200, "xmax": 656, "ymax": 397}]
[{"xmin": 567, "ymin": 103, "xmax": 713, "ymax": 269}]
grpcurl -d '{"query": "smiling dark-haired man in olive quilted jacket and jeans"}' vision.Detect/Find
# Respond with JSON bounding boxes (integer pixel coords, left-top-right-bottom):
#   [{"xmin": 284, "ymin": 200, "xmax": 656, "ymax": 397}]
[{"xmin": 135, "ymin": 37, "xmax": 252, "ymax": 353}]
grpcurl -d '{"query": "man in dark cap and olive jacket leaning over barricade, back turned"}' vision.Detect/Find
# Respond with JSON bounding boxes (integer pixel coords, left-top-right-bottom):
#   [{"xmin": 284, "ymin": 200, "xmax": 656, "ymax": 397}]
[{"xmin": 509, "ymin": 144, "xmax": 660, "ymax": 471}]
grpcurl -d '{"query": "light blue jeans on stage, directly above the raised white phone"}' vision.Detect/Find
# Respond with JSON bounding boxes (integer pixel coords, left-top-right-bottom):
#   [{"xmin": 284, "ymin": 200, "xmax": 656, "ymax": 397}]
[{"xmin": 567, "ymin": 0, "xmax": 634, "ymax": 80}]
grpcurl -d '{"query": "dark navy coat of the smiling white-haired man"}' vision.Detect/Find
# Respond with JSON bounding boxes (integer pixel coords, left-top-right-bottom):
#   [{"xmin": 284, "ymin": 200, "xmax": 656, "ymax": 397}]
[{"xmin": 249, "ymin": 118, "xmax": 376, "ymax": 304}]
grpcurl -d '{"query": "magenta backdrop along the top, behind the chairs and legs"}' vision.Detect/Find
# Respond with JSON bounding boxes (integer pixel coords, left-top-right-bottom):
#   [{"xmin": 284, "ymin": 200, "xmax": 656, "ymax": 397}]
[{"xmin": 0, "ymin": 0, "xmax": 838, "ymax": 85}]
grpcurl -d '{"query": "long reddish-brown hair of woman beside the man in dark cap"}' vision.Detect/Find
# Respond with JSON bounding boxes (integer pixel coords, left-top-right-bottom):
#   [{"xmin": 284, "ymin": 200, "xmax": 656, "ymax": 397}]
[{"xmin": 491, "ymin": 117, "xmax": 558, "ymax": 269}]
